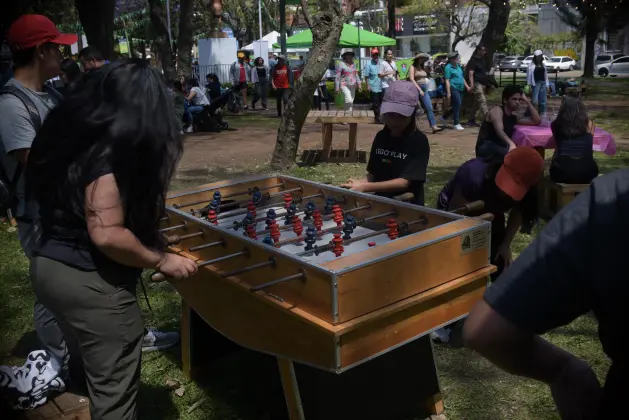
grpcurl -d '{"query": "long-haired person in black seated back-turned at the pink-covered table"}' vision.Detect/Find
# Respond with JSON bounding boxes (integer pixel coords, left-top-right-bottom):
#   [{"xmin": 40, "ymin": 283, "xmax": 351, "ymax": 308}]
[{"xmin": 549, "ymin": 95, "xmax": 598, "ymax": 184}]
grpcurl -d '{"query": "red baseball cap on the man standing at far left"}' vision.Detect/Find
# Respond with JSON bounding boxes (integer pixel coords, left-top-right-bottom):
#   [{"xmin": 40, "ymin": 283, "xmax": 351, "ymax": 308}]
[{"xmin": 7, "ymin": 15, "xmax": 78, "ymax": 50}]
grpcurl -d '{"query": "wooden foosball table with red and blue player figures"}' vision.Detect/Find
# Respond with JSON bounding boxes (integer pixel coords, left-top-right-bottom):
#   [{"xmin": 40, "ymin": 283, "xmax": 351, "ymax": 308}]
[{"xmin": 151, "ymin": 176, "xmax": 495, "ymax": 420}]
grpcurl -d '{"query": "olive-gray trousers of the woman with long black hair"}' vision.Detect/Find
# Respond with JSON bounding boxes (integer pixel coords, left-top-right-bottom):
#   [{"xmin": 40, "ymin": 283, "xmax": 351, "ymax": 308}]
[{"xmin": 31, "ymin": 257, "xmax": 144, "ymax": 420}]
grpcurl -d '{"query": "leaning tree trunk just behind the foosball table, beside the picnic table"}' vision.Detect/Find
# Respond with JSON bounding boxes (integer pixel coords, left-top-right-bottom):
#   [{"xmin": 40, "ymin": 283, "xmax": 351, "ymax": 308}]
[{"xmin": 271, "ymin": 0, "xmax": 343, "ymax": 170}]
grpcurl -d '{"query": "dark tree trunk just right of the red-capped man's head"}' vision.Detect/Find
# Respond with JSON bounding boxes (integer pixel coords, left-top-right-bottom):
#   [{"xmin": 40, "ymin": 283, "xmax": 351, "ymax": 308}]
[{"xmin": 74, "ymin": 0, "xmax": 116, "ymax": 60}]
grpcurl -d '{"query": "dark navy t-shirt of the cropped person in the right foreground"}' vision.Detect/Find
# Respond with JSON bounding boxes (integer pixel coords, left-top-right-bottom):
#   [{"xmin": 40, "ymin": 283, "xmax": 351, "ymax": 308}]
[{"xmin": 484, "ymin": 169, "xmax": 629, "ymax": 412}]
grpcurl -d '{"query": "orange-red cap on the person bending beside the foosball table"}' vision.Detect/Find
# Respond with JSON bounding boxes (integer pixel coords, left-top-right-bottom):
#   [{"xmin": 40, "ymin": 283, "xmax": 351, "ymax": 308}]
[{"xmin": 496, "ymin": 147, "xmax": 544, "ymax": 201}]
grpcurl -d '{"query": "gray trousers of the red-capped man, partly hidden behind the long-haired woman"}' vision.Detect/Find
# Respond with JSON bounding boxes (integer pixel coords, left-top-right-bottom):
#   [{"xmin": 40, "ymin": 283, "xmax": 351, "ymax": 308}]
[{"xmin": 17, "ymin": 221, "xmax": 70, "ymax": 379}]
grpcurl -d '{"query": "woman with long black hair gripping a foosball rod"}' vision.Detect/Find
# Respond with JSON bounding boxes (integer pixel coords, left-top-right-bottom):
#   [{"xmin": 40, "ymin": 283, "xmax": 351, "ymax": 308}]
[{"xmin": 26, "ymin": 62, "xmax": 197, "ymax": 420}]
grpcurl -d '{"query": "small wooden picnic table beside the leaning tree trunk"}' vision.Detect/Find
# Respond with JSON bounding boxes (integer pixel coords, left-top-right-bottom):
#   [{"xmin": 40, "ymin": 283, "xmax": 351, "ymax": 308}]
[{"xmin": 306, "ymin": 111, "xmax": 374, "ymax": 162}]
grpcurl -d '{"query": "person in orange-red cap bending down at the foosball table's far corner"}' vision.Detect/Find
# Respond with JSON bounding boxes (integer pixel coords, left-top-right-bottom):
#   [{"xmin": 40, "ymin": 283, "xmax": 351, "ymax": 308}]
[{"xmin": 431, "ymin": 147, "xmax": 544, "ymax": 342}]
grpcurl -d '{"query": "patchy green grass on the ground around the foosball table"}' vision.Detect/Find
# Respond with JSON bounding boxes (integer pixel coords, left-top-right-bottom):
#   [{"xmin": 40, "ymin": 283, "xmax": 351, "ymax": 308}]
[{"xmin": 0, "ymin": 106, "xmax": 629, "ymax": 420}]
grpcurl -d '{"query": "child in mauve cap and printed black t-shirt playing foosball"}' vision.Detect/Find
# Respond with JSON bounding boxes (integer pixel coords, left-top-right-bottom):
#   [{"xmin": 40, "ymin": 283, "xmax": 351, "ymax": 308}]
[{"xmin": 341, "ymin": 80, "xmax": 430, "ymax": 206}]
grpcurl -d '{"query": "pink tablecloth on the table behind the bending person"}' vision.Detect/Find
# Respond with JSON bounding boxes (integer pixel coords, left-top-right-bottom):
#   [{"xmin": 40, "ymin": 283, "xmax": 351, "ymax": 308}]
[{"xmin": 512, "ymin": 125, "xmax": 616, "ymax": 155}]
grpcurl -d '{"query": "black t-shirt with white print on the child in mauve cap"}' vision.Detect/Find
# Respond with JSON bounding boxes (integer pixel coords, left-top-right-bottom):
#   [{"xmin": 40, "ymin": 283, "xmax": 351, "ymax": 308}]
[{"xmin": 367, "ymin": 128, "xmax": 430, "ymax": 206}]
